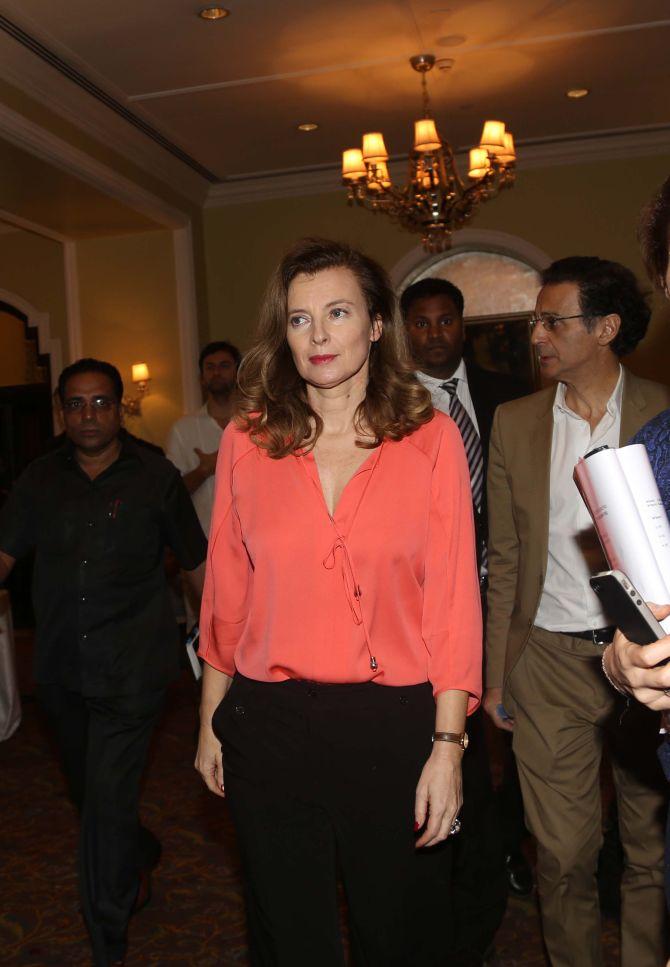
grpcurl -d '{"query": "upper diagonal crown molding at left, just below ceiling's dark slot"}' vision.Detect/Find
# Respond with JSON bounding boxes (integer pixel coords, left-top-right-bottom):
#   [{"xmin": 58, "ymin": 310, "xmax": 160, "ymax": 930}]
[{"xmin": 0, "ymin": 31, "xmax": 209, "ymax": 206}]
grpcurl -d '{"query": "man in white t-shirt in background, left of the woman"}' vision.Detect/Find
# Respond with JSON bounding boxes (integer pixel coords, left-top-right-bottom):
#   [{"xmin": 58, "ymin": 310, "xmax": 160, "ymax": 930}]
[{"xmin": 167, "ymin": 341, "xmax": 241, "ymax": 535}]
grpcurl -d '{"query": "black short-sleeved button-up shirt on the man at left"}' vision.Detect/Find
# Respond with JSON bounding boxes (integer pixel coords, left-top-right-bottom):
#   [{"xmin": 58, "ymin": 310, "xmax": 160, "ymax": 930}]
[{"xmin": 0, "ymin": 433, "xmax": 207, "ymax": 696}]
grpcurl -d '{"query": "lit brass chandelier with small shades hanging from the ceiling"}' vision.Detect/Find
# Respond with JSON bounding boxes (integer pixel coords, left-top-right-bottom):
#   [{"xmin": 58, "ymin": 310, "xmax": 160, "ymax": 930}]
[{"xmin": 342, "ymin": 54, "xmax": 516, "ymax": 252}]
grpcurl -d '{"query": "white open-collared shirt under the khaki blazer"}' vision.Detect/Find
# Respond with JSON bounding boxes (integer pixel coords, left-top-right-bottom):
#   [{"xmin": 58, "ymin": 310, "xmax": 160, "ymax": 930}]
[{"xmin": 535, "ymin": 368, "xmax": 623, "ymax": 631}]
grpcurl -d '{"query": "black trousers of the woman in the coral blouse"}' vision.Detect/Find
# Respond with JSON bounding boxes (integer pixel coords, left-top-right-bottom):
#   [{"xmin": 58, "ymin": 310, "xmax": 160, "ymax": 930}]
[{"xmin": 213, "ymin": 675, "xmax": 450, "ymax": 967}]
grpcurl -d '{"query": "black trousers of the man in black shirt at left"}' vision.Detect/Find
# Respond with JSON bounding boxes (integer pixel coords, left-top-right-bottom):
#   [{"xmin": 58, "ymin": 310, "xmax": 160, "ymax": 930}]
[{"xmin": 38, "ymin": 685, "xmax": 165, "ymax": 967}]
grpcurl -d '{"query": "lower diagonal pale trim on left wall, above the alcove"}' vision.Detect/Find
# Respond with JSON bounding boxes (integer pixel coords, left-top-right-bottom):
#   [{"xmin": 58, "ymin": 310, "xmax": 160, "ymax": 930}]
[{"xmin": 0, "ymin": 104, "xmax": 188, "ymax": 228}]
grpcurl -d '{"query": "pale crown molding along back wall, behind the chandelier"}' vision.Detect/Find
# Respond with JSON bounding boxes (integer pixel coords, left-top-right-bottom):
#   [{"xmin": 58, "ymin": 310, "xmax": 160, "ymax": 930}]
[{"xmin": 205, "ymin": 125, "xmax": 670, "ymax": 208}]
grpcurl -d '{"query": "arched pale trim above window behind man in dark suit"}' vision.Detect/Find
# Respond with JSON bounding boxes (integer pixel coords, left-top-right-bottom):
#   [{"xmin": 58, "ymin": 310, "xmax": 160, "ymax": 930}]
[{"xmin": 389, "ymin": 228, "xmax": 551, "ymax": 293}]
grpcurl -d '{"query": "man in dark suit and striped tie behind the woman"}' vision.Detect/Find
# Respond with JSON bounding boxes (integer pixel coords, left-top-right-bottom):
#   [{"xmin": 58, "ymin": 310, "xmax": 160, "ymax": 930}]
[{"xmin": 400, "ymin": 278, "xmax": 532, "ymax": 967}]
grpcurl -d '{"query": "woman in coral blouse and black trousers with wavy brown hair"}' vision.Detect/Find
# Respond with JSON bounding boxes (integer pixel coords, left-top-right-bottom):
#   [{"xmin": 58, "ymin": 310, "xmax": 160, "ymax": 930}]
[{"xmin": 196, "ymin": 239, "xmax": 481, "ymax": 967}]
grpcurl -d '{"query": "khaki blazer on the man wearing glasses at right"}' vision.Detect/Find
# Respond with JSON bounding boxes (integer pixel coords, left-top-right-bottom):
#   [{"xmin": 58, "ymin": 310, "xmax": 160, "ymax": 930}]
[{"xmin": 485, "ymin": 368, "xmax": 670, "ymax": 688}]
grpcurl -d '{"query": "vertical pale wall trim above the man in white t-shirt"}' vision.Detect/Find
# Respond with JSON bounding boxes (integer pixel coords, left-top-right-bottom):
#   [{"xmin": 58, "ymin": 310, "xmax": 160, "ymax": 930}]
[{"xmin": 172, "ymin": 223, "xmax": 202, "ymax": 413}]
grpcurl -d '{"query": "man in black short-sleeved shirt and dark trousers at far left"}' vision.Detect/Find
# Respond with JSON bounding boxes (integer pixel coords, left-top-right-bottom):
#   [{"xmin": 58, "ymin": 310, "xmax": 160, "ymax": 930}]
[{"xmin": 0, "ymin": 359, "xmax": 207, "ymax": 967}]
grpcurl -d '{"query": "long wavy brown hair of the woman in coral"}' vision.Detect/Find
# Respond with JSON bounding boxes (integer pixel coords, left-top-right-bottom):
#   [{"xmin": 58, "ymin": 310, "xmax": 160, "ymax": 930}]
[{"xmin": 235, "ymin": 238, "xmax": 433, "ymax": 458}]
